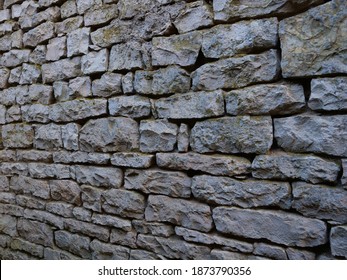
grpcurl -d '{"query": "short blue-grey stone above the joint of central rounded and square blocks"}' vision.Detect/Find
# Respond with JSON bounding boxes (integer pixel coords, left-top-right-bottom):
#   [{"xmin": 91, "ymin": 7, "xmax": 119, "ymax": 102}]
[{"xmin": 108, "ymin": 95, "xmax": 151, "ymax": 118}]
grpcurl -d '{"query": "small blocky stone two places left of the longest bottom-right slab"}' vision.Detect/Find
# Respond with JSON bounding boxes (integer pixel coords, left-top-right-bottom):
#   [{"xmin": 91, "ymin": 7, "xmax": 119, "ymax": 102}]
[{"xmin": 102, "ymin": 189, "xmax": 145, "ymax": 219}]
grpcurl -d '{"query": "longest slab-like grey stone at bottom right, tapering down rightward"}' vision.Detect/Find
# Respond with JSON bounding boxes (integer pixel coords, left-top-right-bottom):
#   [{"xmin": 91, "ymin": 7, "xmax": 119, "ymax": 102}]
[{"xmin": 213, "ymin": 207, "xmax": 327, "ymax": 247}]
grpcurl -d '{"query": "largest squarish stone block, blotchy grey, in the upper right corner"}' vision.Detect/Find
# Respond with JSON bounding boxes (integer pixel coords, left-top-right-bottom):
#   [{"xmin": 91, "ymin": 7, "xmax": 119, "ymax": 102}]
[{"xmin": 279, "ymin": 0, "xmax": 347, "ymax": 78}]
